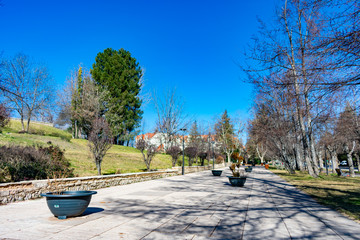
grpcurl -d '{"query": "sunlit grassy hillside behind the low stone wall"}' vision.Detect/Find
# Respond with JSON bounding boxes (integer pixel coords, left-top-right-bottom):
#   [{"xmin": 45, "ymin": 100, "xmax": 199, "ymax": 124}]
[{"xmin": 0, "ymin": 120, "xmax": 171, "ymax": 176}]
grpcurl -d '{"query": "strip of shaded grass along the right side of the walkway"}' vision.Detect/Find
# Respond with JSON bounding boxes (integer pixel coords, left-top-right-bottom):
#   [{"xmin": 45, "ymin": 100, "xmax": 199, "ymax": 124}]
[{"xmin": 271, "ymin": 169, "xmax": 360, "ymax": 221}]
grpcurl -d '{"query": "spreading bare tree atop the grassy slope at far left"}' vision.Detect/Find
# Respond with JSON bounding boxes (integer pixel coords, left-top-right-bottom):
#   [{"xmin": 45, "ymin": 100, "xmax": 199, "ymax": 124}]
[{"xmin": 2, "ymin": 53, "xmax": 54, "ymax": 132}]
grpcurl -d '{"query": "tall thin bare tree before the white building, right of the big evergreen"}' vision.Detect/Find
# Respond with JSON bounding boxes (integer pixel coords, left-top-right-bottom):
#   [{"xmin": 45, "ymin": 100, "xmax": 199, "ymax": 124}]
[{"xmin": 153, "ymin": 89, "xmax": 188, "ymax": 151}]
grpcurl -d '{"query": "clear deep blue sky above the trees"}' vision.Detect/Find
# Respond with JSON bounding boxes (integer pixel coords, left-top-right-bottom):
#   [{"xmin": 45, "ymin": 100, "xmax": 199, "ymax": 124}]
[{"xmin": 0, "ymin": 0, "xmax": 277, "ymax": 131}]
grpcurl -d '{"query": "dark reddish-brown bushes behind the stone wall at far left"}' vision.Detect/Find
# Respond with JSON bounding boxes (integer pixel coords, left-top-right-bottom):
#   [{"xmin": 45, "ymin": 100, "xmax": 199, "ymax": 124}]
[{"xmin": 0, "ymin": 143, "xmax": 73, "ymax": 182}]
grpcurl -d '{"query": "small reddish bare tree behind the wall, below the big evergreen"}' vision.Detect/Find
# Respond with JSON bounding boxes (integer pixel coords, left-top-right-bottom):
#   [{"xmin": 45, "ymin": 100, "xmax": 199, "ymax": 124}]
[{"xmin": 89, "ymin": 117, "xmax": 113, "ymax": 175}]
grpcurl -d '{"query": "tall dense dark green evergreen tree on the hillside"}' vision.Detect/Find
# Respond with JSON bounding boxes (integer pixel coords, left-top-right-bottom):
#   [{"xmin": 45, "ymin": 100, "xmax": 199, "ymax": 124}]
[{"xmin": 91, "ymin": 48, "xmax": 143, "ymax": 145}]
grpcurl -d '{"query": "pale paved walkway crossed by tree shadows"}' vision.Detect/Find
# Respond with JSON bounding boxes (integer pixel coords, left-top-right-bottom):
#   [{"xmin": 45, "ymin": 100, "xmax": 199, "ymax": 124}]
[{"xmin": 0, "ymin": 168, "xmax": 360, "ymax": 240}]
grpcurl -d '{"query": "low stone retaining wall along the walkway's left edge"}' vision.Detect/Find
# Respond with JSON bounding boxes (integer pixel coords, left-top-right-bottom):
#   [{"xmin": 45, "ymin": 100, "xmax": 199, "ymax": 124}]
[{"xmin": 0, "ymin": 170, "xmax": 177, "ymax": 204}]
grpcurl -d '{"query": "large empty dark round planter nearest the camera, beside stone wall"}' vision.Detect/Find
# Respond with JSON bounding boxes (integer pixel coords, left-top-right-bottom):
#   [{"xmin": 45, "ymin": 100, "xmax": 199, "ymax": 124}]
[{"xmin": 41, "ymin": 191, "xmax": 97, "ymax": 219}]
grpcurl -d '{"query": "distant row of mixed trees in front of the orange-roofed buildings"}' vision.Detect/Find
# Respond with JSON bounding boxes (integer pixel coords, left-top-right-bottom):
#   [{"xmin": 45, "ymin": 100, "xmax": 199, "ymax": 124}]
[{"xmin": 153, "ymin": 89, "xmax": 244, "ymax": 166}]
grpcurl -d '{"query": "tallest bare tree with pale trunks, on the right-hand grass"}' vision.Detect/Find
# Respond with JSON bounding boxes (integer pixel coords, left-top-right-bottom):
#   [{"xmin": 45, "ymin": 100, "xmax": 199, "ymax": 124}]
[{"xmin": 244, "ymin": 0, "xmax": 340, "ymax": 177}]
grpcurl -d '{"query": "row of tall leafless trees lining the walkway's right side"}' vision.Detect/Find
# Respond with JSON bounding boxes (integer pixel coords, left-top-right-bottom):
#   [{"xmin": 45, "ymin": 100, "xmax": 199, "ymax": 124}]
[{"xmin": 243, "ymin": 0, "xmax": 360, "ymax": 177}]
